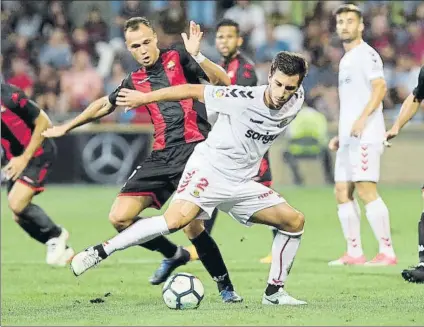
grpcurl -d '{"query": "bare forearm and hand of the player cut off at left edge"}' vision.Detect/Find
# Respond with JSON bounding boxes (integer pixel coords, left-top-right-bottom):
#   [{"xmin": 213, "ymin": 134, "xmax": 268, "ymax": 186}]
[{"xmin": 3, "ymin": 109, "xmax": 52, "ymax": 181}]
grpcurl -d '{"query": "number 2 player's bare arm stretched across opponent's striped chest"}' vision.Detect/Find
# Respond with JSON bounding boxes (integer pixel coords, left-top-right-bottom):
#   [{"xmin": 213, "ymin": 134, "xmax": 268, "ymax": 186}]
[{"xmin": 116, "ymin": 84, "xmax": 205, "ymax": 110}]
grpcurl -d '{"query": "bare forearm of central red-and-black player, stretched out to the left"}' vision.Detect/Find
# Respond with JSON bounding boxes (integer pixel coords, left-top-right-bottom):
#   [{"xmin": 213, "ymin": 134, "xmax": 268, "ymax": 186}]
[{"xmin": 43, "ymin": 96, "xmax": 116, "ymax": 138}]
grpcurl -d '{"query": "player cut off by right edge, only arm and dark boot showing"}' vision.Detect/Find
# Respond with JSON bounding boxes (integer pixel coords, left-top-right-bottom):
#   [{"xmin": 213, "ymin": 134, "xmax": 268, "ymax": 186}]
[{"xmin": 386, "ymin": 66, "xmax": 424, "ymax": 283}]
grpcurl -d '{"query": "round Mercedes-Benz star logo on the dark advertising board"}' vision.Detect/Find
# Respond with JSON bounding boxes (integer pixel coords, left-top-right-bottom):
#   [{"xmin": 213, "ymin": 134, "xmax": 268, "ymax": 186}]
[{"xmin": 82, "ymin": 133, "xmax": 146, "ymax": 183}]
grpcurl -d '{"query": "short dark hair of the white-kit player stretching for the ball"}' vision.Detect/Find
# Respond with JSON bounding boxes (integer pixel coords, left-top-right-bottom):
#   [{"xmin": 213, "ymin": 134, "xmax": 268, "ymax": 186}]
[{"xmin": 269, "ymin": 51, "xmax": 308, "ymax": 85}]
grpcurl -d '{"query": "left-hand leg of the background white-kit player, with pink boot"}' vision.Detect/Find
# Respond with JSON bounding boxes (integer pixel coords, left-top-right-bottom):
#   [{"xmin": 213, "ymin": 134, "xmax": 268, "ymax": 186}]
[{"xmin": 328, "ymin": 147, "xmax": 366, "ymax": 266}]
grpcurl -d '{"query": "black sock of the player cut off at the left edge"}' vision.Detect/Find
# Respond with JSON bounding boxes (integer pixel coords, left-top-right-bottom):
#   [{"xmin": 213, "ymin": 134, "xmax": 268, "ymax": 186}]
[{"xmin": 17, "ymin": 203, "xmax": 62, "ymax": 244}]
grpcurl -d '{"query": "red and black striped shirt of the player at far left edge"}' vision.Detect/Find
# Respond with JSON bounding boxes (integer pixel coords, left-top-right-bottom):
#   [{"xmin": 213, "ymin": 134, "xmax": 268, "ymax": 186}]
[{"xmin": 1, "ymin": 83, "xmax": 56, "ymax": 160}]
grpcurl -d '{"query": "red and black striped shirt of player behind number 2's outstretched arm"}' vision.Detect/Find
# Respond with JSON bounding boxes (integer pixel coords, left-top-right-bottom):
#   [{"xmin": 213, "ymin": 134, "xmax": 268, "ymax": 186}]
[{"xmin": 109, "ymin": 46, "xmax": 210, "ymax": 150}]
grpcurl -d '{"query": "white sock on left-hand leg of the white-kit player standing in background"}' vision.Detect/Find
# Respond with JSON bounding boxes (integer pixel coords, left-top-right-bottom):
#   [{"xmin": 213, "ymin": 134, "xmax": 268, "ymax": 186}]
[{"xmin": 337, "ymin": 200, "xmax": 364, "ymax": 258}]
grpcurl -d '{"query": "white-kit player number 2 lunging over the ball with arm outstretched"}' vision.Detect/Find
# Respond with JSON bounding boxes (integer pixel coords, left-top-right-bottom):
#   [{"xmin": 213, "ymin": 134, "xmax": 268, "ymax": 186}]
[{"xmin": 71, "ymin": 52, "xmax": 308, "ymax": 305}]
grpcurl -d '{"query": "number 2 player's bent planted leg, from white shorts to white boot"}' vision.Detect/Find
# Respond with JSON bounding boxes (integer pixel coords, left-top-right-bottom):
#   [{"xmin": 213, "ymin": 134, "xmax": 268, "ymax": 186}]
[{"xmin": 227, "ymin": 181, "xmax": 306, "ymax": 305}]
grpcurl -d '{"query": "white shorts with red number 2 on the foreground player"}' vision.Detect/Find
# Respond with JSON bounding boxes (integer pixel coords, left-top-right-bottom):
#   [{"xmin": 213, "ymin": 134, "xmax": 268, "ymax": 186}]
[{"xmin": 172, "ymin": 156, "xmax": 286, "ymax": 226}]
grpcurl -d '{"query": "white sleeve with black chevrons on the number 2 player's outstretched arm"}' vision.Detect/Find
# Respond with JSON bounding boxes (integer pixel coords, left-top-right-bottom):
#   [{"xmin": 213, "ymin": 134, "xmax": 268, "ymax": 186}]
[{"xmin": 204, "ymin": 85, "xmax": 250, "ymax": 119}]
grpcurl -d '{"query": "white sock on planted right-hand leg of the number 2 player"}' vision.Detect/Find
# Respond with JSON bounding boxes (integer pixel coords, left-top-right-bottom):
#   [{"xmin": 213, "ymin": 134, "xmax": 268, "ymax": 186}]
[{"xmin": 268, "ymin": 231, "xmax": 303, "ymax": 286}]
